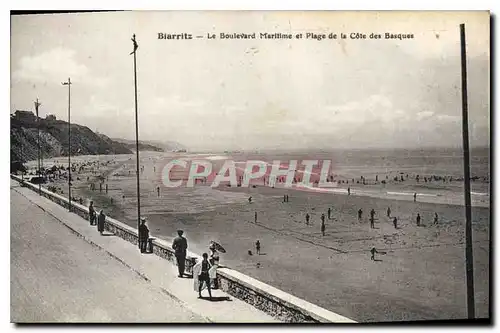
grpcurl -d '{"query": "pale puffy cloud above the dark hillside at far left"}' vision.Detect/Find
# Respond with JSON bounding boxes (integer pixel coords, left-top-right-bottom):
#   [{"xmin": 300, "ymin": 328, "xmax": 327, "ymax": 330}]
[{"xmin": 12, "ymin": 47, "xmax": 110, "ymax": 88}]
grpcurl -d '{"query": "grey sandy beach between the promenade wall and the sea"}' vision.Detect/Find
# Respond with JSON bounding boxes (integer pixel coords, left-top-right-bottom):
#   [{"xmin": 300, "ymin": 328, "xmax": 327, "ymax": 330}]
[{"xmin": 33, "ymin": 155, "xmax": 490, "ymax": 322}]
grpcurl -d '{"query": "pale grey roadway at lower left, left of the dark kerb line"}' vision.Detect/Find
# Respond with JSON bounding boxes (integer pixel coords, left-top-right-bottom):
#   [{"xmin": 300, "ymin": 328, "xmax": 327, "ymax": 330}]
[{"xmin": 10, "ymin": 184, "xmax": 204, "ymax": 323}]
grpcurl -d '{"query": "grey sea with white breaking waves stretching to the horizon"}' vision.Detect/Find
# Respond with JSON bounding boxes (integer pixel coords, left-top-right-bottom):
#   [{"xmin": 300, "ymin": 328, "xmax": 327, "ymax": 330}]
[{"xmin": 28, "ymin": 147, "xmax": 490, "ymax": 207}]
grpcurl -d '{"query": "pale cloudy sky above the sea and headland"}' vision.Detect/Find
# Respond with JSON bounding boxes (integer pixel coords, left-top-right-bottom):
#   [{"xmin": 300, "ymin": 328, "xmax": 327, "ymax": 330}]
[{"xmin": 10, "ymin": 11, "xmax": 490, "ymax": 150}]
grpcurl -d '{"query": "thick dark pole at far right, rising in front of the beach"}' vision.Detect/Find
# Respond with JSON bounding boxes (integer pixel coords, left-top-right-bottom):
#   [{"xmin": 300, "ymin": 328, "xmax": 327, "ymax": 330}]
[{"xmin": 460, "ymin": 24, "xmax": 475, "ymax": 319}]
